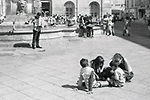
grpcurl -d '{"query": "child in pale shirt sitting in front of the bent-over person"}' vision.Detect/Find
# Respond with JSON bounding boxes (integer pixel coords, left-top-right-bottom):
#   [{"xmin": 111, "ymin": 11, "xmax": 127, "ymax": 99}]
[{"xmin": 107, "ymin": 62, "xmax": 125, "ymax": 87}]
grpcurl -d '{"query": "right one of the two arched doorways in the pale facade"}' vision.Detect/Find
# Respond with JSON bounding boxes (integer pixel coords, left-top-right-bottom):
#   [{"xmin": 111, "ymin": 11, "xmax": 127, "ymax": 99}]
[{"xmin": 89, "ymin": 1, "xmax": 100, "ymax": 18}]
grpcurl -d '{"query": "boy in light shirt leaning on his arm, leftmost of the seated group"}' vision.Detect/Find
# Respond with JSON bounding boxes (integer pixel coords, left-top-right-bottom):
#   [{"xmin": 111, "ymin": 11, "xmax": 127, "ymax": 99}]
[{"xmin": 77, "ymin": 58, "xmax": 108, "ymax": 94}]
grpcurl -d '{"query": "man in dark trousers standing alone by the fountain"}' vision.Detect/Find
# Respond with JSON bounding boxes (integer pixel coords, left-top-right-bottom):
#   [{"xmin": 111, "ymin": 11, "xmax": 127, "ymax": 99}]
[{"xmin": 32, "ymin": 12, "xmax": 42, "ymax": 49}]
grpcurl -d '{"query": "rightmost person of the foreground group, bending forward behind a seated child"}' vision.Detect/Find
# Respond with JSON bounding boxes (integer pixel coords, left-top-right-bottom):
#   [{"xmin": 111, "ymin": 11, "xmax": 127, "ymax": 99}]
[{"xmin": 111, "ymin": 53, "xmax": 134, "ymax": 82}]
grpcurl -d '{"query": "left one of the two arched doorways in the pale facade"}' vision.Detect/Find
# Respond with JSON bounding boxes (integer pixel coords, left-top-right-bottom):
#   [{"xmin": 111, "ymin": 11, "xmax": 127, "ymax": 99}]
[{"xmin": 64, "ymin": 1, "xmax": 75, "ymax": 17}]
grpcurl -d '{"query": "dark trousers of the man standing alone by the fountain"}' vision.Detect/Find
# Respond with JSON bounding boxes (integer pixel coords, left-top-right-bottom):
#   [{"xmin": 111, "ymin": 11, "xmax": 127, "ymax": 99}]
[{"xmin": 32, "ymin": 30, "xmax": 41, "ymax": 46}]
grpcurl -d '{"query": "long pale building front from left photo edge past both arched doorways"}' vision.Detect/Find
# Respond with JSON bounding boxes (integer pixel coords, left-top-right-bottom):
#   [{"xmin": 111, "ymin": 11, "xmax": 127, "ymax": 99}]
[{"xmin": 0, "ymin": 0, "xmax": 111, "ymax": 17}]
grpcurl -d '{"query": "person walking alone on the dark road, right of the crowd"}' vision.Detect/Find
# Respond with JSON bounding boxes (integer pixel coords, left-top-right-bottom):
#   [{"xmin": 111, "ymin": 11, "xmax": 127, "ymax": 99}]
[{"xmin": 123, "ymin": 16, "xmax": 130, "ymax": 36}]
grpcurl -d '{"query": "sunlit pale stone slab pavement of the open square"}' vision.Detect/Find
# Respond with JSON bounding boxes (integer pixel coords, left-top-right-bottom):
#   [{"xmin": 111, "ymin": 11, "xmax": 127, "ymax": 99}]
[{"xmin": 0, "ymin": 30, "xmax": 150, "ymax": 100}]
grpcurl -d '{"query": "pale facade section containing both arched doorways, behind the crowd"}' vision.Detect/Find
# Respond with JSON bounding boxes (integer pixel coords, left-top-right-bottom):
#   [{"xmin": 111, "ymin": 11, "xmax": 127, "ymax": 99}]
[{"xmin": 52, "ymin": 0, "xmax": 111, "ymax": 17}]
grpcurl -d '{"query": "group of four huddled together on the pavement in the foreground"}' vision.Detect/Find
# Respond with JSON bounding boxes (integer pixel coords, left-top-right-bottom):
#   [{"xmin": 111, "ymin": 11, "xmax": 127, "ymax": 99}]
[{"xmin": 77, "ymin": 53, "xmax": 134, "ymax": 94}]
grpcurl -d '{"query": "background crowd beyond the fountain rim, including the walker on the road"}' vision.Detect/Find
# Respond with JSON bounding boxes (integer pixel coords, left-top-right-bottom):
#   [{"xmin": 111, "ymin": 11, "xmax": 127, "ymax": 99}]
[{"xmin": 25, "ymin": 13, "xmax": 141, "ymax": 37}]
